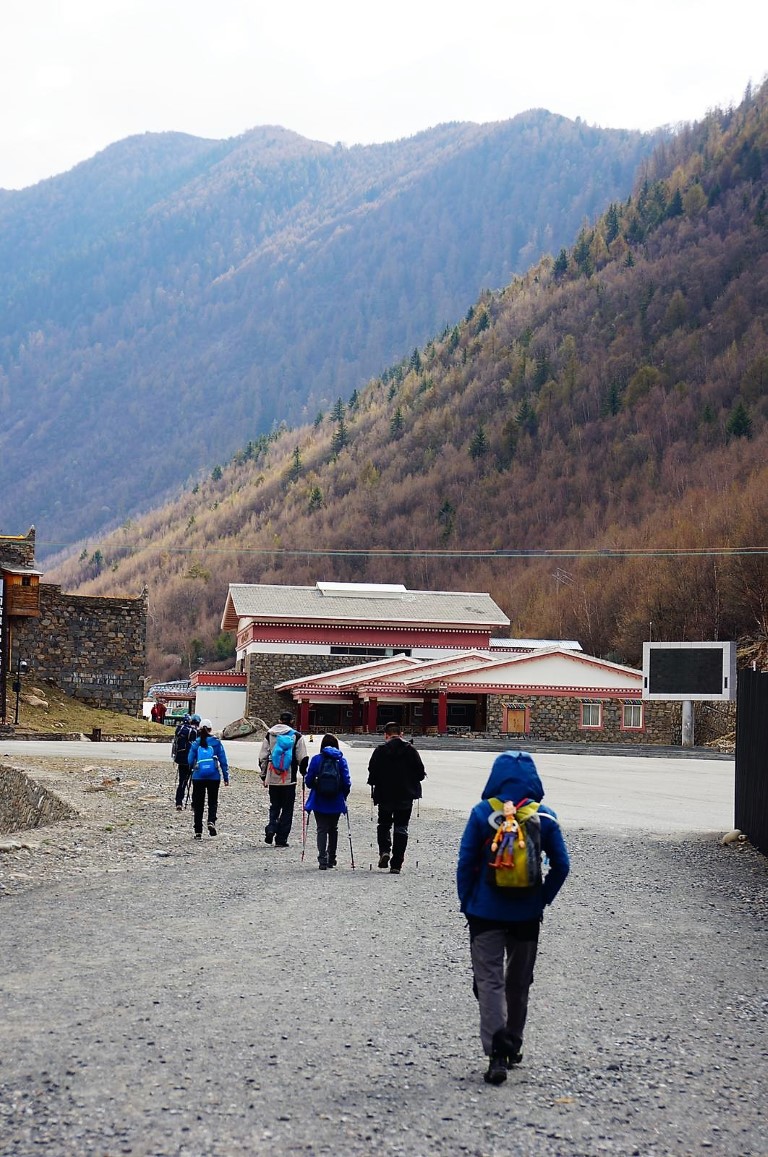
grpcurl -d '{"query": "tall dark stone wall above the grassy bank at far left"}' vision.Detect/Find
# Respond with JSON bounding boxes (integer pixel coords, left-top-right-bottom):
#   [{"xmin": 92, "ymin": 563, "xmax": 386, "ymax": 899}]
[{"xmin": 12, "ymin": 583, "xmax": 147, "ymax": 715}]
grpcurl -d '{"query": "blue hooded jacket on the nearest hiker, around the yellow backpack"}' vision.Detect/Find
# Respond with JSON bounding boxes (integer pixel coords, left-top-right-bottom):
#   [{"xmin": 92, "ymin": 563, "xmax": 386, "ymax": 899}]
[{"xmin": 456, "ymin": 751, "xmax": 570, "ymax": 923}]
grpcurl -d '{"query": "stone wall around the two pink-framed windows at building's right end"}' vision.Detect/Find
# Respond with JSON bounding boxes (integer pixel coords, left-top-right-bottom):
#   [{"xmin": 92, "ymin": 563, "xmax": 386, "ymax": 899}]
[{"xmin": 488, "ymin": 695, "xmax": 682, "ymax": 746}]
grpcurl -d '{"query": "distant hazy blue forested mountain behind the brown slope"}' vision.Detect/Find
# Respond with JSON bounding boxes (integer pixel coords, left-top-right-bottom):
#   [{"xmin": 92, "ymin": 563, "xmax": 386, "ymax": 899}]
[{"xmin": 0, "ymin": 110, "xmax": 659, "ymax": 541}]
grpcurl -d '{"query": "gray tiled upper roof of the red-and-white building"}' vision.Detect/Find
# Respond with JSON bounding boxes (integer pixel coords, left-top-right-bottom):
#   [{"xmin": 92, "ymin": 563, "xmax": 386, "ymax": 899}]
[{"xmin": 222, "ymin": 583, "xmax": 509, "ymax": 631}]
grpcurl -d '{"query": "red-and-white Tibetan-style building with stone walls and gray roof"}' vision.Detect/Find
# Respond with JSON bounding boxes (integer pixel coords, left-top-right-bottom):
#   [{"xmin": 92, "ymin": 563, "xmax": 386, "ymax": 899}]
[{"xmin": 217, "ymin": 582, "xmax": 679, "ymax": 743}]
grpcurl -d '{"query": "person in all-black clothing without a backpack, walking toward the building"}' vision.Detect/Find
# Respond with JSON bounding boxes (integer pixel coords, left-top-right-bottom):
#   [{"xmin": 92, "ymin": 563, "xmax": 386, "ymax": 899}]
[{"xmin": 368, "ymin": 723, "xmax": 427, "ymax": 875}]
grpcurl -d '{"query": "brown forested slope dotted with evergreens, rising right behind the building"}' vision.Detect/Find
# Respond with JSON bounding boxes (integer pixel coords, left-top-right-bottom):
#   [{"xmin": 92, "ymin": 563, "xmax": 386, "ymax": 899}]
[{"xmin": 50, "ymin": 87, "xmax": 768, "ymax": 673}]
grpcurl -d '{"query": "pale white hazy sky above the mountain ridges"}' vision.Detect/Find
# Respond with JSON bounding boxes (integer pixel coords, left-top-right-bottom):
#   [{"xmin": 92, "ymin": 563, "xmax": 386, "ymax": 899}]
[{"xmin": 0, "ymin": 0, "xmax": 768, "ymax": 189}]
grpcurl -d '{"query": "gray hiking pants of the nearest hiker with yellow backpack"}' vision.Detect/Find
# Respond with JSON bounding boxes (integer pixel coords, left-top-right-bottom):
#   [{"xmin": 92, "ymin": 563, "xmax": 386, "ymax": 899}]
[{"xmin": 470, "ymin": 928, "xmax": 539, "ymax": 1056}]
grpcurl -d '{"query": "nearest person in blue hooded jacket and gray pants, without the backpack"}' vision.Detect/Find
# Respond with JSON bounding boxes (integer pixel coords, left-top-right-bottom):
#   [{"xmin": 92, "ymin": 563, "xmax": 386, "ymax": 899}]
[{"xmin": 456, "ymin": 751, "xmax": 570, "ymax": 1084}]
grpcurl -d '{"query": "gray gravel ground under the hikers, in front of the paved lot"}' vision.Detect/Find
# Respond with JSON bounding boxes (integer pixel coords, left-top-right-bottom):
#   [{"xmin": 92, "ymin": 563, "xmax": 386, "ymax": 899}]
[{"xmin": 0, "ymin": 745, "xmax": 768, "ymax": 1157}]
